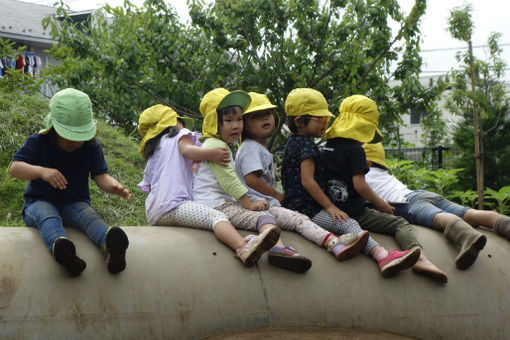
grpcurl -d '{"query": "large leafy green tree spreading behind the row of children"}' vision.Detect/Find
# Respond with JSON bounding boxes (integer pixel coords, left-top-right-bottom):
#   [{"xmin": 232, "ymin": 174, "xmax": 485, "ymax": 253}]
[{"xmin": 45, "ymin": 0, "xmax": 442, "ymax": 151}]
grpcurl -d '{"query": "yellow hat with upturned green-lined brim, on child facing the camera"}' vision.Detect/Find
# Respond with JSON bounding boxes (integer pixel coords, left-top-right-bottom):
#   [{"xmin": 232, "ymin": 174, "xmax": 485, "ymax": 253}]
[{"xmin": 200, "ymin": 87, "xmax": 251, "ymax": 138}]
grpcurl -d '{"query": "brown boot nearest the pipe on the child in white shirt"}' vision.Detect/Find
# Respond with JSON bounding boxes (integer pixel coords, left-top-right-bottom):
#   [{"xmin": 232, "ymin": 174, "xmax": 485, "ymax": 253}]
[{"xmin": 444, "ymin": 218, "xmax": 487, "ymax": 270}]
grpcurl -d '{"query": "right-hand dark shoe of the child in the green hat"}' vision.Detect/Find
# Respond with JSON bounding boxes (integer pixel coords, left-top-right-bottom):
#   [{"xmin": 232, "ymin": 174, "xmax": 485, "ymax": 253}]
[{"xmin": 105, "ymin": 227, "xmax": 129, "ymax": 274}]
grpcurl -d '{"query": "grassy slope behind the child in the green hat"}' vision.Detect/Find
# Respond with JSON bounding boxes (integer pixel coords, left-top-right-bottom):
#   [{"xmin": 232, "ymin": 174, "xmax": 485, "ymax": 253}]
[{"xmin": 0, "ymin": 93, "xmax": 147, "ymax": 226}]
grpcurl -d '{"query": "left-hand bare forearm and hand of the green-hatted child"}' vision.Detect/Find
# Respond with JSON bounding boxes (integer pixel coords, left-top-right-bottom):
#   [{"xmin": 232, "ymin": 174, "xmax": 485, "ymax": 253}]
[{"xmin": 10, "ymin": 161, "xmax": 67, "ymax": 190}]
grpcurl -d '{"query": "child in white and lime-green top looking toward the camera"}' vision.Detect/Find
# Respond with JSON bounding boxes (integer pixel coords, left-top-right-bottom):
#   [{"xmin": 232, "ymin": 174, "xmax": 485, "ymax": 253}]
[{"xmin": 193, "ymin": 88, "xmax": 312, "ymax": 273}]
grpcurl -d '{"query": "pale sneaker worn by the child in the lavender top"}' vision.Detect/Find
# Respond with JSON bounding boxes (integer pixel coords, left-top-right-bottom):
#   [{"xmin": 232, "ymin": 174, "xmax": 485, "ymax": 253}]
[{"xmin": 236, "ymin": 225, "xmax": 280, "ymax": 267}]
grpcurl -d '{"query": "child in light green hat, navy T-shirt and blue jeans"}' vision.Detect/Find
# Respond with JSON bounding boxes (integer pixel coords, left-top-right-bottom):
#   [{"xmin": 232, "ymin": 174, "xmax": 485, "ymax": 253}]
[{"xmin": 10, "ymin": 88, "xmax": 132, "ymax": 277}]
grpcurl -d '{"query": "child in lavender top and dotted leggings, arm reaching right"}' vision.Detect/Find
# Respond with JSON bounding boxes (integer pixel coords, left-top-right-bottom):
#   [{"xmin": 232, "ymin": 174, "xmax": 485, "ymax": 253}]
[{"xmin": 138, "ymin": 105, "xmax": 278, "ymax": 266}]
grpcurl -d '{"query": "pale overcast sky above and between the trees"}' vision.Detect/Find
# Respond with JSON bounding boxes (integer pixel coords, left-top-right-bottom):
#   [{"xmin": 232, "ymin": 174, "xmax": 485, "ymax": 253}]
[{"xmin": 18, "ymin": 0, "xmax": 510, "ymax": 82}]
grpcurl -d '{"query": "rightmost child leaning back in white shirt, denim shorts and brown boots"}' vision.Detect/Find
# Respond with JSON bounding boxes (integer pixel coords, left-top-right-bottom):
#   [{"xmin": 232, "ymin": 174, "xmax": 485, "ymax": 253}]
[{"xmin": 363, "ymin": 143, "xmax": 510, "ymax": 269}]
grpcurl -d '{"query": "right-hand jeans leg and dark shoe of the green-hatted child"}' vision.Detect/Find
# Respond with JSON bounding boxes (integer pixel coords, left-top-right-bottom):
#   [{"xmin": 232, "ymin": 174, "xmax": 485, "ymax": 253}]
[{"xmin": 61, "ymin": 202, "xmax": 129, "ymax": 274}]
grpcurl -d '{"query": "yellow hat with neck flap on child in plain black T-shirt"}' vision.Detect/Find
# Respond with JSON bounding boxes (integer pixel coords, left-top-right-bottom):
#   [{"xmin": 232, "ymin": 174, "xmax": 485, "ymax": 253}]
[{"xmin": 326, "ymin": 94, "xmax": 383, "ymax": 143}]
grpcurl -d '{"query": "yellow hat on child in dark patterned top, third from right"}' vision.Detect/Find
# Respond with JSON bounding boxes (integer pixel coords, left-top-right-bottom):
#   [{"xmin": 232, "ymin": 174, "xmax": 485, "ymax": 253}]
[{"xmin": 285, "ymin": 88, "xmax": 334, "ymax": 117}]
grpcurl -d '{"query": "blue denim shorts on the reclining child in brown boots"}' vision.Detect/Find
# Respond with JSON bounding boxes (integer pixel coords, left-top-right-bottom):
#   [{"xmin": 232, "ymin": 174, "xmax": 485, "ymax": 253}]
[{"xmin": 395, "ymin": 190, "xmax": 469, "ymax": 228}]
